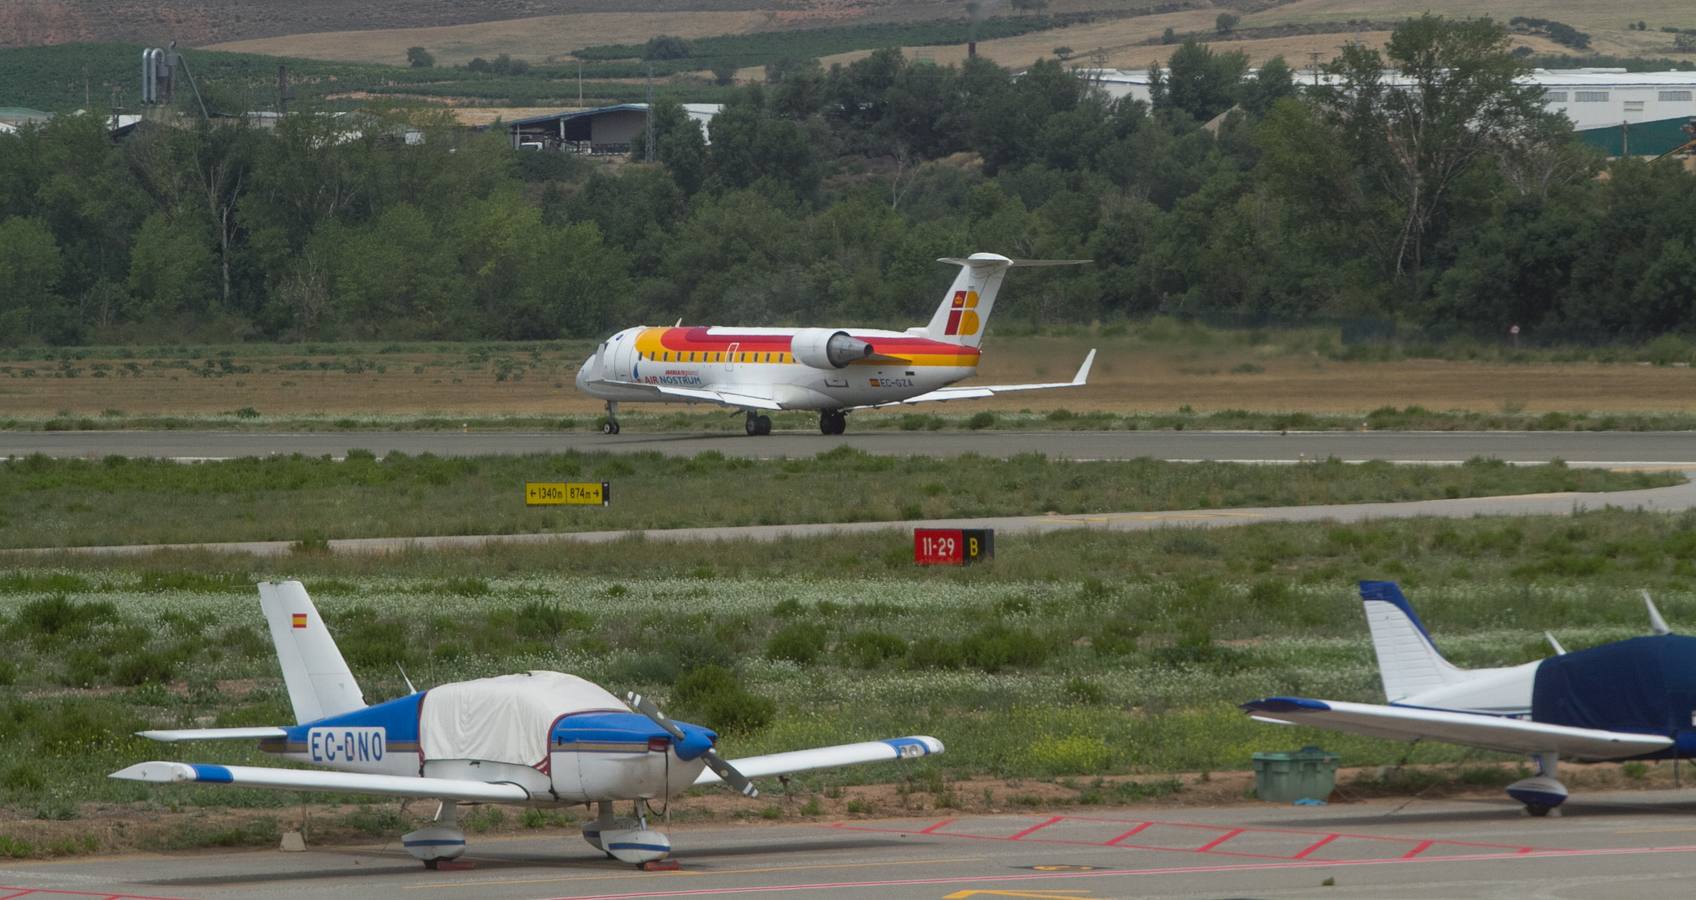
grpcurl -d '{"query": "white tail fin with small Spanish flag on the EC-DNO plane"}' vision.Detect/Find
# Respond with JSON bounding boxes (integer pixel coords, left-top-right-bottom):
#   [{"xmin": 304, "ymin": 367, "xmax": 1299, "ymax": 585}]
[{"xmin": 259, "ymin": 581, "xmax": 365, "ymax": 722}]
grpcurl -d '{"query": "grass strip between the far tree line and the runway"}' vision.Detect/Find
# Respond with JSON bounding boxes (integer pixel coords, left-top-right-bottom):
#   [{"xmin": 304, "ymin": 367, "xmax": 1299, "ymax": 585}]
[{"xmin": 0, "ymin": 320, "xmax": 1696, "ymax": 423}]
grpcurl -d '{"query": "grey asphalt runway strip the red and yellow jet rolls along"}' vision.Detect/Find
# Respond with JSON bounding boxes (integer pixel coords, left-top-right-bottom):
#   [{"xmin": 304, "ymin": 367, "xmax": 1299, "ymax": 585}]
[{"xmin": 0, "ymin": 432, "xmax": 1696, "ymax": 468}]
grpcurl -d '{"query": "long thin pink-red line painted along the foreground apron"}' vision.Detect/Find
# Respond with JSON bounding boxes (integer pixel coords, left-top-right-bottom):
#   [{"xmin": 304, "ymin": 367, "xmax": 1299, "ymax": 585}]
[{"xmin": 549, "ymin": 846, "xmax": 1696, "ymax": 900}]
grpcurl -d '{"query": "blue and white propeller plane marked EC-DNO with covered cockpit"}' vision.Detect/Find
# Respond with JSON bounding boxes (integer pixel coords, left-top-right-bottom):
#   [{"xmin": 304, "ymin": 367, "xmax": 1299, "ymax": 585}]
[{"xmin": 112, "ymin": 581, "xmax": 943, "ymax": 868}]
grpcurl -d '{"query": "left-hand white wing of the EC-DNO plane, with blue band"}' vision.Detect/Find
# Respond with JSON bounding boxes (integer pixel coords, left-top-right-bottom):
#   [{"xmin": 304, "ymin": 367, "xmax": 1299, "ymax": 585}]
[{"xmin": 107, "ymin": 761, "xmax": 529, "ymax": 803}]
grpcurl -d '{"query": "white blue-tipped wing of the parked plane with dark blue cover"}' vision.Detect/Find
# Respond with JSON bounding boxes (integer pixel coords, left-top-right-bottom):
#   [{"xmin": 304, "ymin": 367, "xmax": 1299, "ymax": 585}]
[{"xmin": 1241, "ymin": 697, "xmax": 1672, "ymax": 761}]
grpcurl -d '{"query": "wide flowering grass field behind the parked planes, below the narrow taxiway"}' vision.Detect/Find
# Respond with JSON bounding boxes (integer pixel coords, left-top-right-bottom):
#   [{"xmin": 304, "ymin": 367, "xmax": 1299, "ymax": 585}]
[{"xmin": 0, "ymin": 510, "xmax": 1696, "ymax": 854}]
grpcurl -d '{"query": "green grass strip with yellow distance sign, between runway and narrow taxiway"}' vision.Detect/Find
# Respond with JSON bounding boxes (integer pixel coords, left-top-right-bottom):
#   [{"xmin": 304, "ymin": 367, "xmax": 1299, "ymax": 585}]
[{"xmin": 0, "ymin": 447, "xmax": 1677, "ymax": 547}]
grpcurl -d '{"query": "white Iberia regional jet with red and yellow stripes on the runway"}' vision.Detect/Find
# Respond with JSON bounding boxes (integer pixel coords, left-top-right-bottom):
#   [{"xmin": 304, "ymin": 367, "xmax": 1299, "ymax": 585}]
[{"xmin": 577, "ymin": 253, "xmax": 1096, "ymax": 437}]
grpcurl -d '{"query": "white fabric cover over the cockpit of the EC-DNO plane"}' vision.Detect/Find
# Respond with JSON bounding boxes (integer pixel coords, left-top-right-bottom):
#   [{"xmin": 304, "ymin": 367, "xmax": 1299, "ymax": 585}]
[{"xmin": 419, "ymin": 671, "xmax": 629, "ymax": 766}]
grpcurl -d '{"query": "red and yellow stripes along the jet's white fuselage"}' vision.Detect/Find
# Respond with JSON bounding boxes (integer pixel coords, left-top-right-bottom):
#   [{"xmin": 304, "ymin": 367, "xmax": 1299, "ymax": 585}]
[{"xmin": 636, "ymin": 327, "xmax": 979, "ymax": 368}]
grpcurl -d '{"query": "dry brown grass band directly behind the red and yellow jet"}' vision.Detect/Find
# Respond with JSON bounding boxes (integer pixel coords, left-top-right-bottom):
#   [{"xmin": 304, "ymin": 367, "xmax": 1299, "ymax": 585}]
[{"xmin": 0, "ymin": 336, "xmax": 1696, "ymax": 417}]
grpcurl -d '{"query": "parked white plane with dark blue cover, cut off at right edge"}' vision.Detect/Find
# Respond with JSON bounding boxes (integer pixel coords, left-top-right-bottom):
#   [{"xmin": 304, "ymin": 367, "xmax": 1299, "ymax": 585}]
[{"xmin": 1241, "ymin": 581, "xmax": 1696, "ymax": 815}]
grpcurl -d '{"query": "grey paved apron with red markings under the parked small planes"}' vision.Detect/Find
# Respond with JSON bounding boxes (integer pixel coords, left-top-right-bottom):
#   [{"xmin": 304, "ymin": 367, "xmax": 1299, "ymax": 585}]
[{"xmin": 0, "ymin": 790, "xmax": 1696, "ymax": 900}]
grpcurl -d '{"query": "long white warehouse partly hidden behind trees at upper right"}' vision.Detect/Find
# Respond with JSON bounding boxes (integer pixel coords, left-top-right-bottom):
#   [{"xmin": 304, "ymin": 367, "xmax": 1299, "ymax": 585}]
[{"xmin": 1077, "ymin": 68, "xmax": 1696, "ymax": 156}]
